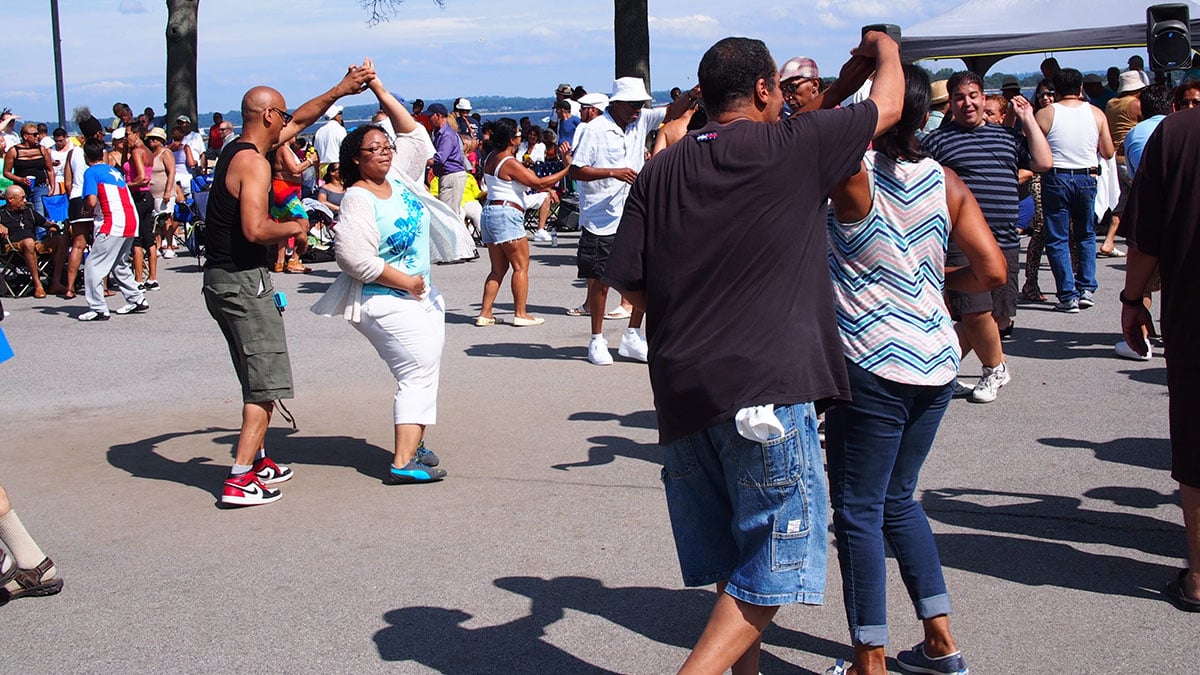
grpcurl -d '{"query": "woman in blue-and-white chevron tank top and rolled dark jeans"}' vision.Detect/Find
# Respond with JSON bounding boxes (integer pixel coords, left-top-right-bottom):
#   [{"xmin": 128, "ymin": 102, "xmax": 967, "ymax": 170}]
[{"xmin": 826, "ymin": 65, "xmax": 1006, "ymax": 674}]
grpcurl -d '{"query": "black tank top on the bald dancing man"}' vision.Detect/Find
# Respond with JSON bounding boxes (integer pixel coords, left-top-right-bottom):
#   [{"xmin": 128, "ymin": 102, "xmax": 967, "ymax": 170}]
[{"xmin": 204, "ymin": 142, "xmax": 270, "ymax": 271}]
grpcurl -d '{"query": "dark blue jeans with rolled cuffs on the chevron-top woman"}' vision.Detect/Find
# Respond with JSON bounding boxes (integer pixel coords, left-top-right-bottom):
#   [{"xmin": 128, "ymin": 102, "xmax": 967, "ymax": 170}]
[{"xmin": 826, "ymin": 360, "xmax": 953, "ymax": 646}]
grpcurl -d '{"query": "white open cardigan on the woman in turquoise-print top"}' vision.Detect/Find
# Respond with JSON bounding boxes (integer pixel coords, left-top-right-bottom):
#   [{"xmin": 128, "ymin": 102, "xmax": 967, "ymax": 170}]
[{"xmin": 310, "ymin": 126, "xmax": 465, "ymax": 323}]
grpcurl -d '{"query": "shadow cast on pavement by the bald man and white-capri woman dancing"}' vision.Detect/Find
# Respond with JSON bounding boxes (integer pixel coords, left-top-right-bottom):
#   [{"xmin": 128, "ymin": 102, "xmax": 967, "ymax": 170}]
[{"xmin": 107, "ymin": 426, "xmax": 392, "ymax": 497}]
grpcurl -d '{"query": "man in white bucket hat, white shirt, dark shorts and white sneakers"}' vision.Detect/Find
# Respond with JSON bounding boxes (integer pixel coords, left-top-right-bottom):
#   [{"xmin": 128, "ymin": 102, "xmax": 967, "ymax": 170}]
[{"xmin": 568, "ymin": 77, "xmax": 691, "ymax": 365}]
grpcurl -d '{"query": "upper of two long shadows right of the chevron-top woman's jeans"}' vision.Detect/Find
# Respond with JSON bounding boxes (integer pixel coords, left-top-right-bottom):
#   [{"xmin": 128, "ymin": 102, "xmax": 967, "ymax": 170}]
[{"xmin": 922, "ymin": 488, "xmax": 1186, "ymax": 560}]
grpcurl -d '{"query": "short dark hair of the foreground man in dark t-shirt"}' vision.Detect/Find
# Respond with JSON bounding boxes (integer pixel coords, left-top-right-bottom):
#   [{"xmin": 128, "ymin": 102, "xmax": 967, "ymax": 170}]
[{"xmin": 697, "ymin": 37, "xmax": 778, "ymax": 117}]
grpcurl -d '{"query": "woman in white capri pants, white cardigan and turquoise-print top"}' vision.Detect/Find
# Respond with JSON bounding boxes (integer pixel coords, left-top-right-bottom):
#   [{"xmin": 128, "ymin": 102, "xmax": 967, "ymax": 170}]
[{"xmin": 313, "ymin": 63, "xmax": 445, "ymax": 484}]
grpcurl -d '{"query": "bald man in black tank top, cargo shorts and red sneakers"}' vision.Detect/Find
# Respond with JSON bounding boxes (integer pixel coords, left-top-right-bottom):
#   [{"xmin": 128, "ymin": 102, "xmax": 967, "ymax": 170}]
[{"xmin": 204, "ymin": 60, "xmax": 374, "ymax": 506}]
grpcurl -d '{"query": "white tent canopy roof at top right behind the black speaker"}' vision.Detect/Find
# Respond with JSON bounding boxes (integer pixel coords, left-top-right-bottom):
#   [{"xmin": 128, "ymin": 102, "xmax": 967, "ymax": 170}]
[{"xmin": 900, "ymin": 0, "xmax": 1200, "ymax": 74}]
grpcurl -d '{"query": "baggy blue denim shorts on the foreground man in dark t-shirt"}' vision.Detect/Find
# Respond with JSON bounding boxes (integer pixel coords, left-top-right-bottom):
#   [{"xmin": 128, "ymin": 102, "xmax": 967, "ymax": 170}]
[{"xmin": 662, "ymin": 404, "xmax": 829, "ymax": 605}]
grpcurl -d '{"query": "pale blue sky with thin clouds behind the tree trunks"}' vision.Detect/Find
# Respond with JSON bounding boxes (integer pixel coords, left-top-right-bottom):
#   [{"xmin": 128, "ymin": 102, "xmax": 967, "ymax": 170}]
[{"xmin": 7, "ymin": 0, "xmax": 1152, "ymax": 120}]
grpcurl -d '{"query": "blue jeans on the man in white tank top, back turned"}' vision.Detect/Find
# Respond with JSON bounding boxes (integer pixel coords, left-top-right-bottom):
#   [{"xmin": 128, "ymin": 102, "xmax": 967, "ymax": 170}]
[{"xmin": 1042, "ymin": 172, "xmax": 1096, "ymax": 300}]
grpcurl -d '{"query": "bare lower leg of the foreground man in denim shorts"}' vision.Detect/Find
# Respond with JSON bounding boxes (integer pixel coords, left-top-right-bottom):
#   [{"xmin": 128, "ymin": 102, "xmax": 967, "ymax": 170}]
[{"xmin": 679, "ymin": 584, "xmax": 779, "ymax": 675}]
